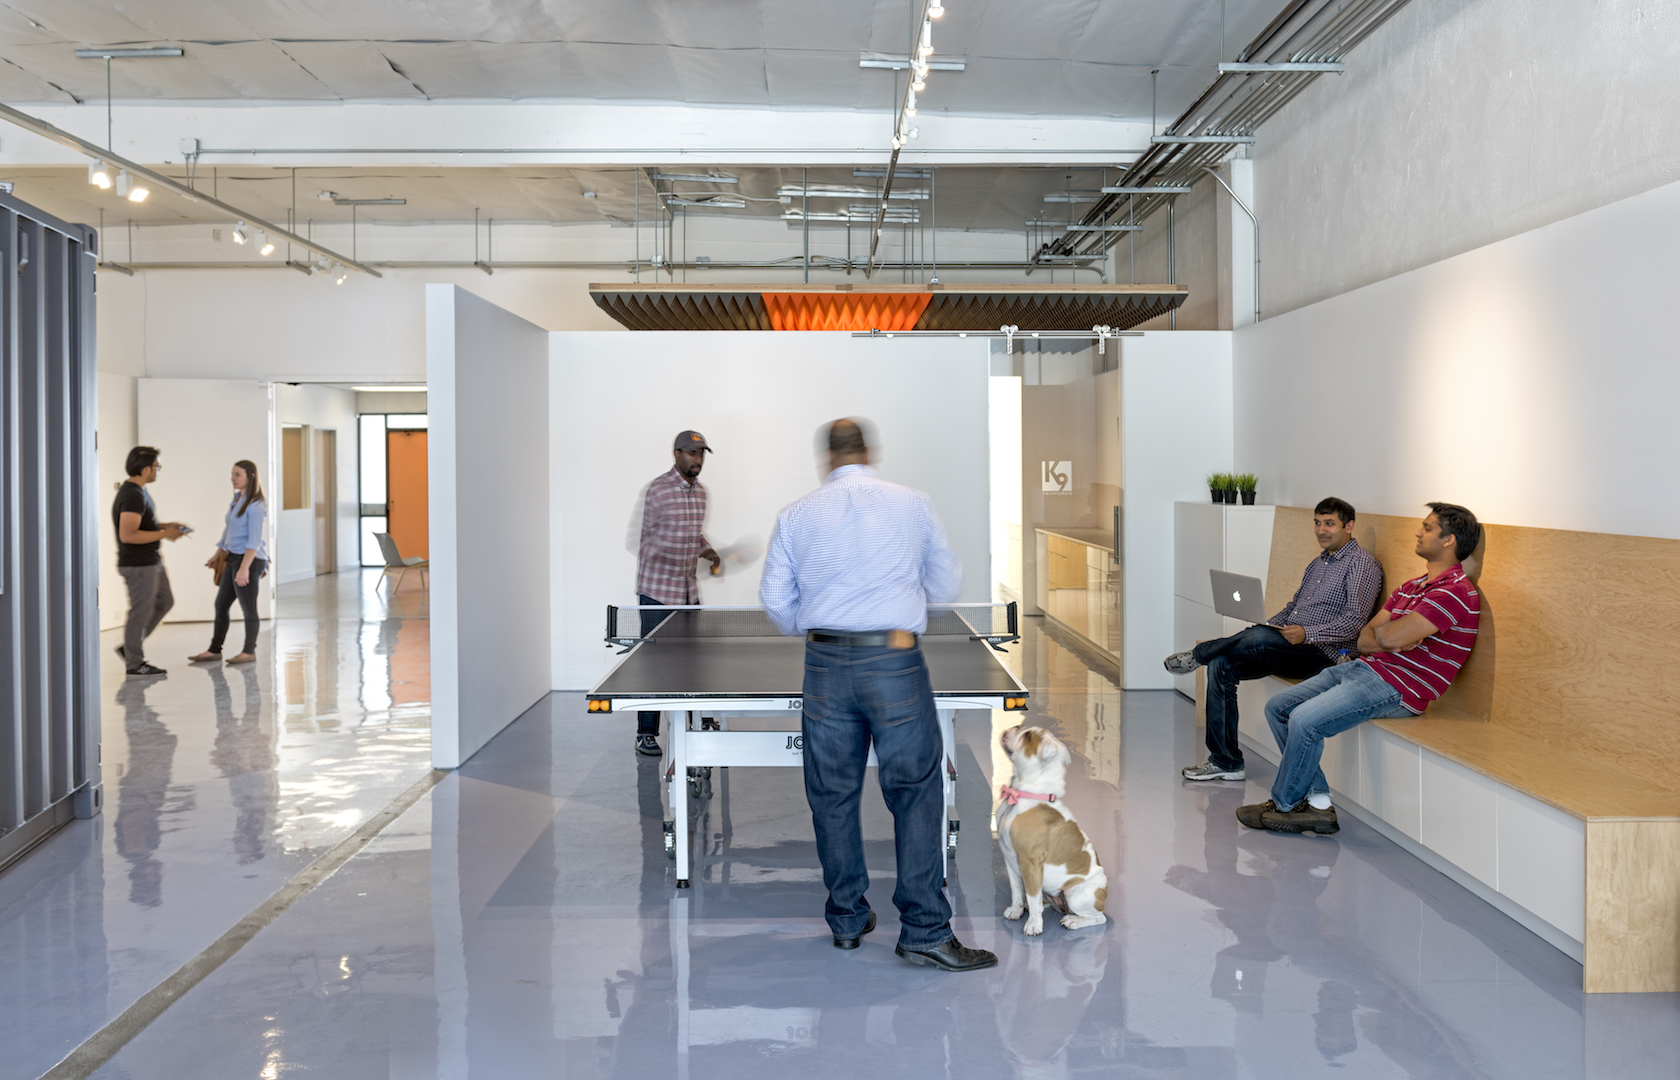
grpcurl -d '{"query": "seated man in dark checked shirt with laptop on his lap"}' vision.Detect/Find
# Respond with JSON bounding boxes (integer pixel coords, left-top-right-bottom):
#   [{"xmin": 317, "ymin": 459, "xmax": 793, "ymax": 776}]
[{"xmin": 1166, "ymin": 497, "xmax": 1383, "ymax": 781}]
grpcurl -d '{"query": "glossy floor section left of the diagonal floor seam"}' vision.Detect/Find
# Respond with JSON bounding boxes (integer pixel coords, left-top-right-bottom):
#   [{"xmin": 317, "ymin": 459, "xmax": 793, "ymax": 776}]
[{"xmin": 0, "ymin": 571, "xmax": 430, "ymax": 1080}]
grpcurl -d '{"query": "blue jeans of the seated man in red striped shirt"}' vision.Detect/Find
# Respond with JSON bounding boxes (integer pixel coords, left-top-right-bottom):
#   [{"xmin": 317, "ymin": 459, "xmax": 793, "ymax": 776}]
[{"xmin": 1265, "ymin": 660, "xmax": 1413, "ymax": 810}]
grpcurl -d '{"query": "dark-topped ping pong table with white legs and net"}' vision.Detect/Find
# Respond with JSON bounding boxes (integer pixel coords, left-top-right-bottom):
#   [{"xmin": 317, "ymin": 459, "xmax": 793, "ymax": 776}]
[{"xmin": 586, "ymin": 603, "xmax": 1026, "ymax": 889}]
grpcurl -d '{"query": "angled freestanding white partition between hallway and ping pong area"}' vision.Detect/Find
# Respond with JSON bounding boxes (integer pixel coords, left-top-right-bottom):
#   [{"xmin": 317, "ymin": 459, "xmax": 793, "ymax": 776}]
[{"xmin": 426, "ymin": 286, "xmax": 551, "ymax": 769}]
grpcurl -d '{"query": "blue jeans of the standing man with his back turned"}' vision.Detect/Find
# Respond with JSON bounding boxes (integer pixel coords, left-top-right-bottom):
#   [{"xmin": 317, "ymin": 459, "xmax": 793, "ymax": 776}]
[{"xmin": 801, "ymin": 642, "xmax": 953, "ymax": 949}]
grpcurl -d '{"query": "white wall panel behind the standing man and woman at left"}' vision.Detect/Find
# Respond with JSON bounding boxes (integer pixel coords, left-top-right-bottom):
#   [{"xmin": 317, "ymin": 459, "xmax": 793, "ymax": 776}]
[{"xmin": 134, "ymin": 378, "xmax": 281, "ymax": 624}]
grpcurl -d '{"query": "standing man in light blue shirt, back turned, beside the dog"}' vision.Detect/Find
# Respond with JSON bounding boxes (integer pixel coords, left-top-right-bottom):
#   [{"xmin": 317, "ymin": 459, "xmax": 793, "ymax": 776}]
[{"xmin": 758, "ymin": 420, "xmax": 998, "ymax": 971}]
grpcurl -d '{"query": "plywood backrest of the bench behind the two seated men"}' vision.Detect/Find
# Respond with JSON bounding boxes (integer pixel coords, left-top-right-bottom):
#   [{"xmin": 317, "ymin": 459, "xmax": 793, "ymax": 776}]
[{"xmin": 1267, "ymin": 507, "xmax": 1680, "ymax": 789}]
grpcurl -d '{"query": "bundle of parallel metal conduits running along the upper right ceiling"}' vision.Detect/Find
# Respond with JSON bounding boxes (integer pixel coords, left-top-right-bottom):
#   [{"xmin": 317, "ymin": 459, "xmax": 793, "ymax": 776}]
[{"xmin": 1032, "ymin": 0, "xmax": 1406, "ymax": 275}]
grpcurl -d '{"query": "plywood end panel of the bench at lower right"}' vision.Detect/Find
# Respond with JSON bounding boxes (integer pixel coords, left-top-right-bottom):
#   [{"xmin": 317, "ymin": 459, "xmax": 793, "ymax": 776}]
[{"xmin": 1581, "ymin": 821, "xmax": 1680, "ymax": 994}]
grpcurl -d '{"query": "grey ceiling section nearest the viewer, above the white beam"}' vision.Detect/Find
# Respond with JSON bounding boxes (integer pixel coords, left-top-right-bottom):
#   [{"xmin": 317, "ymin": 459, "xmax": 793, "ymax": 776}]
[{"xmin": 0, "ymin": 0, "xmax": 1282, "ymax": 118}]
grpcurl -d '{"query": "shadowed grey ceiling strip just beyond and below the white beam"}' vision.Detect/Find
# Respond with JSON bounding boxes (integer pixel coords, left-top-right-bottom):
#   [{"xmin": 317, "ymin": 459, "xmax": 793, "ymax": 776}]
[{"xmin": 3, "ymin": 166, "xmax": 1142, "ymax": 232}]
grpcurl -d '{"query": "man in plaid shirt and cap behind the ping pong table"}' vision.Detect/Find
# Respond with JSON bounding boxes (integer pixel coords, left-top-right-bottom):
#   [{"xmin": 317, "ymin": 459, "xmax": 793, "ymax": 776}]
[{"xmin": 635, "ymin": 432, "xmax": 722, "ymax": 758}]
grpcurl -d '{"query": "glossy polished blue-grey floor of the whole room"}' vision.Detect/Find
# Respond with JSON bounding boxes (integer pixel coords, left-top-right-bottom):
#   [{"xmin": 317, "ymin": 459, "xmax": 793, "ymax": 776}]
[{"xmin": 0, "ymin": 590, "xmax": 1680, "ymax": 1080}]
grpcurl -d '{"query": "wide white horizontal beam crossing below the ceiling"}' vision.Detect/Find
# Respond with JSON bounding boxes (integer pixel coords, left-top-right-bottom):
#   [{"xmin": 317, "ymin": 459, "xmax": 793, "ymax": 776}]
[{"xmin": 0, "ymin": 96, "xmax": 1149, "ymax": 168}]
